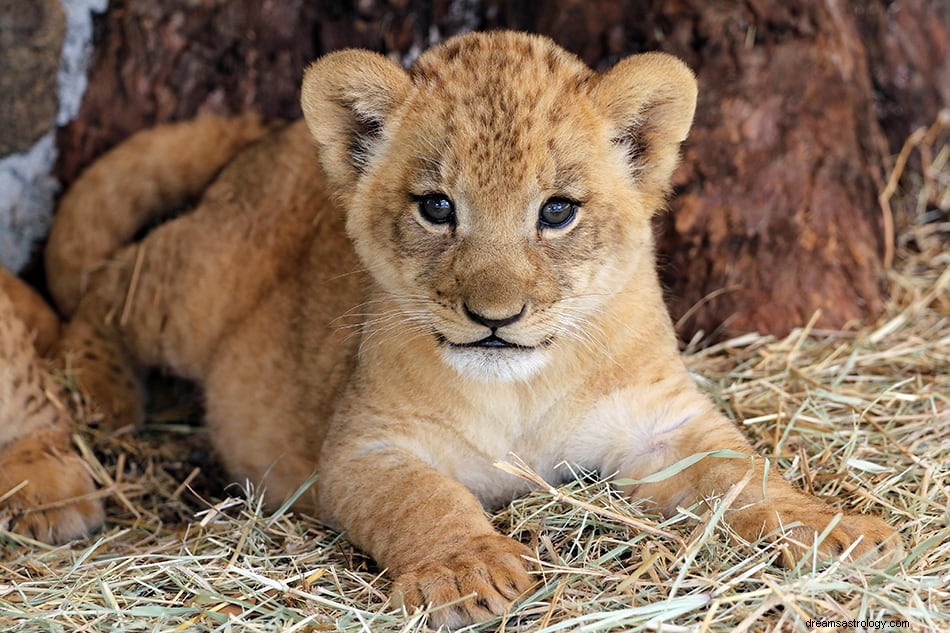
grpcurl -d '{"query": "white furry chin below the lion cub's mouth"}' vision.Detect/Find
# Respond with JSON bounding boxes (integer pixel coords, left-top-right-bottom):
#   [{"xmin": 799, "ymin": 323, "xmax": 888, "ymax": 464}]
[{"xmin": 442, "ymin": 345, "xmax": 549, "ymax": 382}]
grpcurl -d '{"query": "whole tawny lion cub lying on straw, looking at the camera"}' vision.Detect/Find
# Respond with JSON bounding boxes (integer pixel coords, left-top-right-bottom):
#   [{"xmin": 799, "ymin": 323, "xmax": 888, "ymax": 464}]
[{"xmin": 47, "ymin": 32, "xmax": 892, "ymax": 627}]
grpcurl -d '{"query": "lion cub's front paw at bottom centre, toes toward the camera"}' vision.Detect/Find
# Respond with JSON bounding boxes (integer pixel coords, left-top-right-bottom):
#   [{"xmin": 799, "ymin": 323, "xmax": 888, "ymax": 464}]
[{"xmin": 393, "ymin": 534, "xmax": 533, "ymax": 629}]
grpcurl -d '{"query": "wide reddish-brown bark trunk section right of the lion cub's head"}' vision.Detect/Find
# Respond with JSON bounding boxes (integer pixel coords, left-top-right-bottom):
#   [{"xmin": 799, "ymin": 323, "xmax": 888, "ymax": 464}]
[{"xmin": 661, "ymin": 2, "xmax": 883, "ymax": 332}]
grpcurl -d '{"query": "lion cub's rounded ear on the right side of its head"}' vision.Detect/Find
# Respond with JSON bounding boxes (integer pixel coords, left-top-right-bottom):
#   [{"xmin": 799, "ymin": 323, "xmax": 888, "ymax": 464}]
[{"xmin": 590, "ymin": 53, "xmax": 696, "ymax": 205}]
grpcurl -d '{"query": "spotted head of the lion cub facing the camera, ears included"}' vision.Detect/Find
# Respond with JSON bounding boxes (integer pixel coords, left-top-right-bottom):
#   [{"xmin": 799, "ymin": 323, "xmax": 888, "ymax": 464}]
[{"xmin": 302, "ymin": 32, "xmax": 696, "ymax": 380}]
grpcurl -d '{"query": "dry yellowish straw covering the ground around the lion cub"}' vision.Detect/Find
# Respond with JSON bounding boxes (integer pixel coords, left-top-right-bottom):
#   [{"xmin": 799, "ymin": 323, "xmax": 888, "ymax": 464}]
[{"xmin": 0, "ymin": 126, "xmax": 950, "ymax": 632}]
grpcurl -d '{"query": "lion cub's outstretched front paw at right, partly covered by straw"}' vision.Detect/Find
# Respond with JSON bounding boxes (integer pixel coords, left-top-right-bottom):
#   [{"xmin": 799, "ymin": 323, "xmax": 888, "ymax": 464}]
[{"xmin": 729, "ymin": 495, "xmax": 903, "ymax": 567}]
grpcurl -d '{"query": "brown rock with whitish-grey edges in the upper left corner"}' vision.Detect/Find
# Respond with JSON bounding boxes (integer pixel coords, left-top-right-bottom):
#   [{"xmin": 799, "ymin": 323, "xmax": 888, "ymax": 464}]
[{"xmin": 0, "ymin": 0, "xmax": 108, "ymax": 271}]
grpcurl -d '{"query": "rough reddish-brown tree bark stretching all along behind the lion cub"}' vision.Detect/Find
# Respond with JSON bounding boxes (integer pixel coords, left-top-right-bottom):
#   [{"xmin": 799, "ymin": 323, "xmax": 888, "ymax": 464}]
[{"xmin": 59, "ymin": 0, "xmax": 950, "ymax": 335}]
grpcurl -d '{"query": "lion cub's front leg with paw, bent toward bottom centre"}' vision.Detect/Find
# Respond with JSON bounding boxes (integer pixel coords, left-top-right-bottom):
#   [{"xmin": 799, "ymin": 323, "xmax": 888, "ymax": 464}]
[{"xmin": 320, "ymin": 424, "xmax": 532, "ymax": 628}]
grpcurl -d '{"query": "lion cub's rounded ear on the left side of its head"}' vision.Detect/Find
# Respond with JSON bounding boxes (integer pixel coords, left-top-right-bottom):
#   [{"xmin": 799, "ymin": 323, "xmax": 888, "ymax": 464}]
[{"xmin": 300, "ymin": 50, "xmax": 410, "ymax": 190}]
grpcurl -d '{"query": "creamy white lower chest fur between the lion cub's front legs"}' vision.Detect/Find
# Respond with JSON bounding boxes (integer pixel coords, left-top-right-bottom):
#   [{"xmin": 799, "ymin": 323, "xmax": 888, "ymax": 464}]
[{"xmin": 430, "ymin": 380, "xmax": 699, "ymax": 507}]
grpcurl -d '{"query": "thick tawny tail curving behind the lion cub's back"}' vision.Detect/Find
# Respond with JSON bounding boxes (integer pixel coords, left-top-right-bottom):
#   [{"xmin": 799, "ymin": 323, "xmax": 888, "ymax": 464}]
[{"xmin": 46, "ymin": 115, "xmax": 266, "ymax": 316}]
